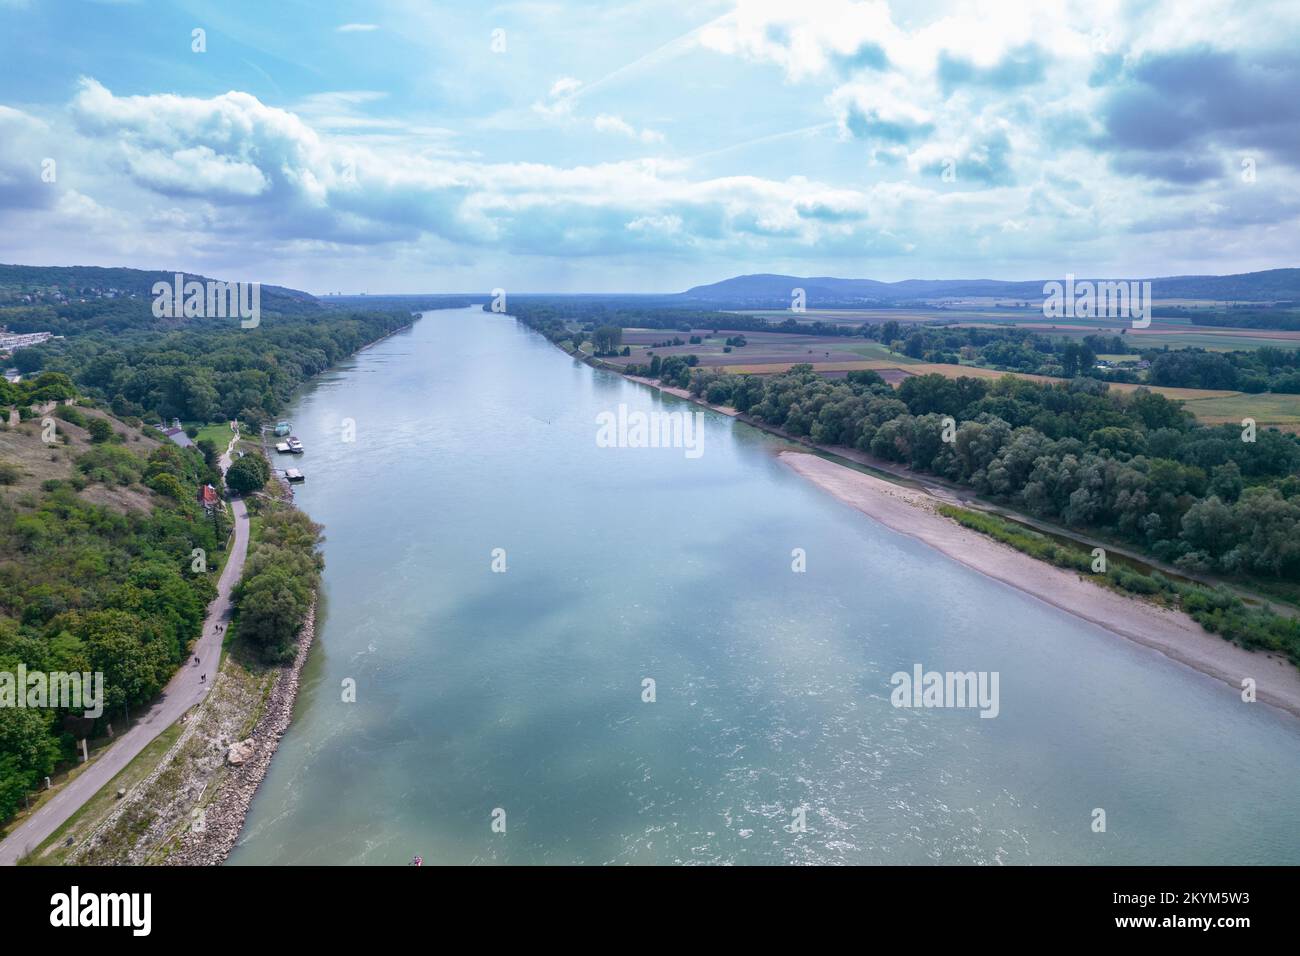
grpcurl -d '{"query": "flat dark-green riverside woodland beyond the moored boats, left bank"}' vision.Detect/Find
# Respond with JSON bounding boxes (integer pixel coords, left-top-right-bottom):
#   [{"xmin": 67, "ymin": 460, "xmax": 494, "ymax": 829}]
[{"xmin": 14, "ymin": 310, "xmax": 411, "ymax": 427}]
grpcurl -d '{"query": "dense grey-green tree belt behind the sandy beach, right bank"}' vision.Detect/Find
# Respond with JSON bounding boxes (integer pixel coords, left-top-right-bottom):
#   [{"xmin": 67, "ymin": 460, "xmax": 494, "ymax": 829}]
[{"xmin": 690, "ymin": 365, "xmax": 1300, "ymax": 581}]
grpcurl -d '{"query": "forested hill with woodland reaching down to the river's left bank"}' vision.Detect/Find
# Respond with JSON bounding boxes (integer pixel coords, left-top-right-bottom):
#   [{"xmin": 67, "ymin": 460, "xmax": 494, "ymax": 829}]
[{"xmin": 0, "ymin": 265, "xmax": 411, "ymax": 425}]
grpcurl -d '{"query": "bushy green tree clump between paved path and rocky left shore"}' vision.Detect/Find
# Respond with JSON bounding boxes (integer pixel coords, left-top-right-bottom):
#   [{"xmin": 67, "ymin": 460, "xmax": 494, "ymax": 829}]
[{"xmin": 234, "ymin": 502, "xmax": 325, "ymax": 663}]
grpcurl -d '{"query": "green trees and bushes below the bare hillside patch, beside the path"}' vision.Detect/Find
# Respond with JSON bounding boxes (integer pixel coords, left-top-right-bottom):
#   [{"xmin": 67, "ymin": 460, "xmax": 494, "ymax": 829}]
[{"xmin": 0, "ymin": 434, "xmax": 229, "ymax": 822}]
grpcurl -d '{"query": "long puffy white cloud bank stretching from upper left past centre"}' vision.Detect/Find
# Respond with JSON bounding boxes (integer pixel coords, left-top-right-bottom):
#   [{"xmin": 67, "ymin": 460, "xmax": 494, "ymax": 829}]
[{"xmin": 38, "ymin": 78, "xmax": 915, "ymax": 255}]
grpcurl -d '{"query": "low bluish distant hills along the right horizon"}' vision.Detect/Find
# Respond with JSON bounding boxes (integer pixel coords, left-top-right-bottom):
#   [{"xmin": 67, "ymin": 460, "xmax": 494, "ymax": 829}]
[{"xmin": 676, "ymin": 269, "xmax": 1300, "ymax": 308}]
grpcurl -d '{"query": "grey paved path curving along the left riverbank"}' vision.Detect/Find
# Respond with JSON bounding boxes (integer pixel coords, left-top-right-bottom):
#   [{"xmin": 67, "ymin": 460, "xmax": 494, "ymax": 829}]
[{"xmin": 0, "ymin": 429, "xmax": 248, "ymax": 866}]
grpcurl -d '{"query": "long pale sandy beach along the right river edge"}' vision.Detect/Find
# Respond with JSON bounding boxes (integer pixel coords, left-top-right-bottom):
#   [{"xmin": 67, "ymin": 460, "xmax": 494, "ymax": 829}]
[{"xmin": 780, "ymin": 451, "xmax": 1300, "ymax": 717}]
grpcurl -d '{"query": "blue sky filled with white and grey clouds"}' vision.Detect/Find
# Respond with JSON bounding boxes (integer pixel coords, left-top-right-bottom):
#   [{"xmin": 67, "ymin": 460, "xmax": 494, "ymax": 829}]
[{"xmin": 0, "ymin": 0, "xmax": 1300, "ymax": 294}]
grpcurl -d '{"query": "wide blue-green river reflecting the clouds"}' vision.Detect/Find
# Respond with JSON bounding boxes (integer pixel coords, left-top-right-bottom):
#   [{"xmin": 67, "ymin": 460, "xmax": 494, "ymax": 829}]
[{"xmin": 231, "ymin": 310, "xmax": 1300, "ymax": 864}]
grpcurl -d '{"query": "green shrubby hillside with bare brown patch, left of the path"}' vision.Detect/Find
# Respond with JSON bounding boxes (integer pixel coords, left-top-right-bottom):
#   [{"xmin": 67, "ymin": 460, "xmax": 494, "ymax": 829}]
[{"xmin": 0, "ymin": 400, "xmax": 230, "ymax": 827}]
